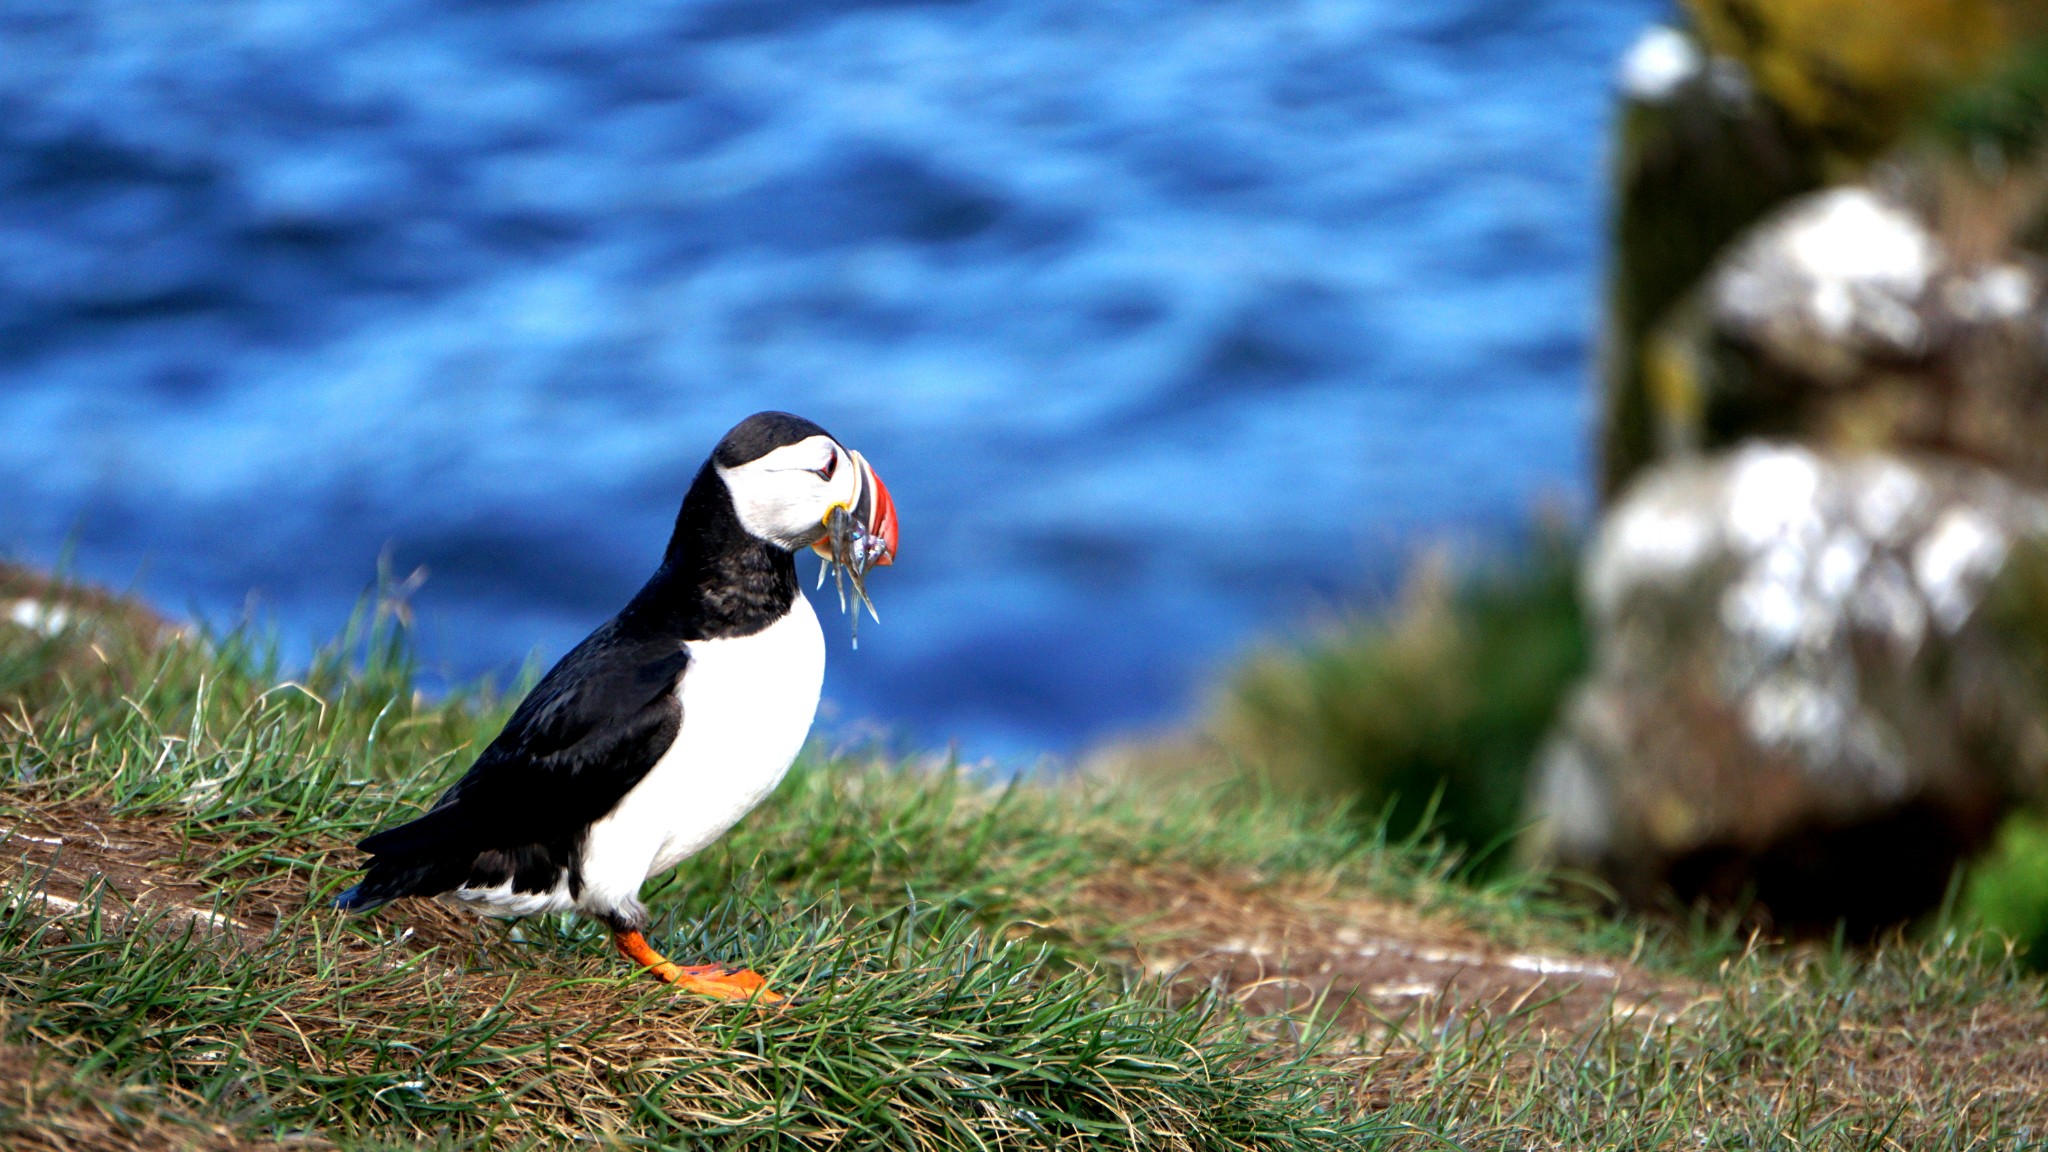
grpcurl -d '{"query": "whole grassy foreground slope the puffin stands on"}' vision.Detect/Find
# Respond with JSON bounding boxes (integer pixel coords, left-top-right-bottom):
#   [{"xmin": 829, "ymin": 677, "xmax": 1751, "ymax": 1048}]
[{"xmin": 0, "ymin": 565, "xmax": 2048, "ymax": 1150}]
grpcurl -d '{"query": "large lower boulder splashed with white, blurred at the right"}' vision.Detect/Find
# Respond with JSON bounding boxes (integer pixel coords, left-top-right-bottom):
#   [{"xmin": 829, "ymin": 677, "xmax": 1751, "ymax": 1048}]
[{"xmin": 1532, "ymin": 443, "xmax": 2048, "ymax": 929}]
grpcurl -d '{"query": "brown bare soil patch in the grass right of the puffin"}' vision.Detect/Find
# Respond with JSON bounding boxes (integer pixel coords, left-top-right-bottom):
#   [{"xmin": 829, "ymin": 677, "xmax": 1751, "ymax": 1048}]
[{"xmin": 1083, "ymin": 871, "xmax": 1700, "ymax": 1033}]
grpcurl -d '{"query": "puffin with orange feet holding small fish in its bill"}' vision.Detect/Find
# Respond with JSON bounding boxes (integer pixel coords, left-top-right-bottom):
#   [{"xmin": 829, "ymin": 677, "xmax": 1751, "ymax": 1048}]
[{"xmin": 334, "ymin": 412, "xmax": 897, "ymax": 1002}]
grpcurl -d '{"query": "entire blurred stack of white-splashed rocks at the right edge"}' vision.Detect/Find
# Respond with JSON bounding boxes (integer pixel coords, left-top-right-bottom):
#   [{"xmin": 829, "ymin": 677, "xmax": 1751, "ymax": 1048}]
[{"xmin": 1524, "ymin": 13, "xmax": 2048, "ymax": 931}]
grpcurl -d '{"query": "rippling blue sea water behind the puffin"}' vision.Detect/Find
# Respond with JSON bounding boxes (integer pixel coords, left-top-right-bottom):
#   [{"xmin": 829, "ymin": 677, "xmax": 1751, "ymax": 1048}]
[{"xmin": 0, "ymin": 0, "xmax": 1667, "ymax": 756}]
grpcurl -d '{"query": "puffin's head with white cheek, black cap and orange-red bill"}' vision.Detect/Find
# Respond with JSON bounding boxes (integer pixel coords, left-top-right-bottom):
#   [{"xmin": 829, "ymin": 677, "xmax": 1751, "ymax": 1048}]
[{"xmin": 711, "ymin": 412, "xmax": 897, "ymax": 564}]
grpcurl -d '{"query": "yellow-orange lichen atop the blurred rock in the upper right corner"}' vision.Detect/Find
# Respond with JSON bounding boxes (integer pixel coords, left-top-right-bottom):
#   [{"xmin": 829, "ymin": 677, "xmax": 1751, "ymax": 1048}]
[{"xmin": 1686, "ymin": 0, "xmax": 2048, "ymax": 160}]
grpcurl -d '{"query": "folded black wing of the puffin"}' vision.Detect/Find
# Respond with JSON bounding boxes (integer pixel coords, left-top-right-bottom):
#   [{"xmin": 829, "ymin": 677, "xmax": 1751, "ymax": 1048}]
[{"xmin": 358, "ymin": 619, "xmax": 690, "ymax": 857}]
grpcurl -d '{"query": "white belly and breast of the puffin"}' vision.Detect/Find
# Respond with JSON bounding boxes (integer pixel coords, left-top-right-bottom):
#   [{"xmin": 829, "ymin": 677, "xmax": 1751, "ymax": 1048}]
[{"xmin": 578, "ymin": 592, "xmax": 825, "ymax": 912}]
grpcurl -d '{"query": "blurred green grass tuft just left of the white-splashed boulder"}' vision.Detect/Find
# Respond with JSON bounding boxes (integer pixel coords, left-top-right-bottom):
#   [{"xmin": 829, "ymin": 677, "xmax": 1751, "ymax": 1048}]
[{"xmin": 1198, "ymin": 529, "xmax": 1587, "ymax": 865}]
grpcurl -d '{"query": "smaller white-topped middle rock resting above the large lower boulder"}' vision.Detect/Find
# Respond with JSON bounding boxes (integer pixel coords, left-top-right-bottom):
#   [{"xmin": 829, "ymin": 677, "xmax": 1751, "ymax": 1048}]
[{"xmin": 1649, "ymin": 174, "xmax": 2048, "ymax": 484}]
